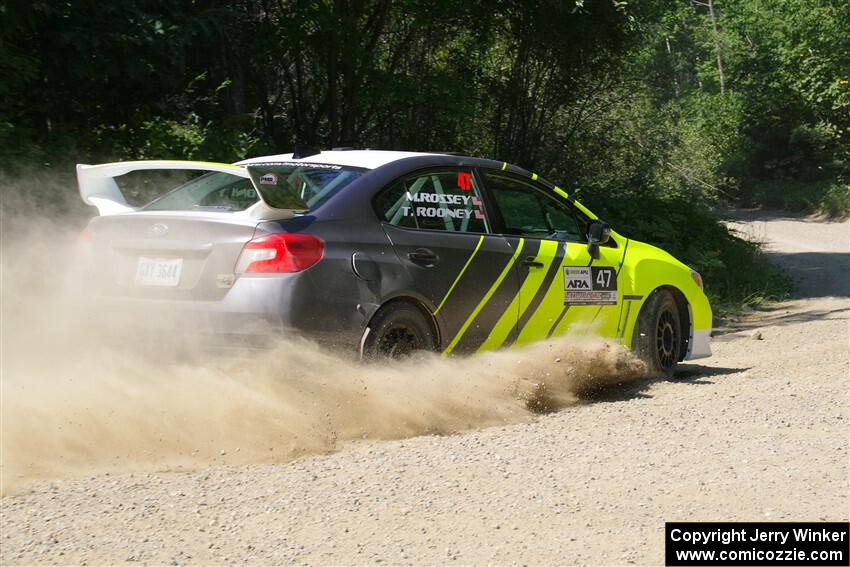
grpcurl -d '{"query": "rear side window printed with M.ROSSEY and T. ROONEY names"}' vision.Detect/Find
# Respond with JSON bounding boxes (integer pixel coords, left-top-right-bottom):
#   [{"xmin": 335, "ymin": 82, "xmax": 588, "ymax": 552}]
[{"xmin": 375, "ymin": 169, "xmax": 489, "ymax": 232}]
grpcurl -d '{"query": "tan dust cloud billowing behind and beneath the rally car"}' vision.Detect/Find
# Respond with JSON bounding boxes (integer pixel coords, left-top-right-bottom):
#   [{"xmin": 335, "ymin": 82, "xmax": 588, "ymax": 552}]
[{"xmin": 0, "ymin": 171, "xmax": 644, "ymax": 494}]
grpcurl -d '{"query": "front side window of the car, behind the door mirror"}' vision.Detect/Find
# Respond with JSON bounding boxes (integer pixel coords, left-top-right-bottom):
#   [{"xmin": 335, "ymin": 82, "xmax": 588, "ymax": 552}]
[{"xmin": 484, "ymin": 173, "xmax": 587, "ymax": 242}]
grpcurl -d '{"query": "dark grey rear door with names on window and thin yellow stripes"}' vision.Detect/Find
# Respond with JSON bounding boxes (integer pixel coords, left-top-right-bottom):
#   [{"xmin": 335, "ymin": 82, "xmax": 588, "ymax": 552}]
[{"xmin": 375, "ymin": 167, "xmax": 519, "ymax": 354}]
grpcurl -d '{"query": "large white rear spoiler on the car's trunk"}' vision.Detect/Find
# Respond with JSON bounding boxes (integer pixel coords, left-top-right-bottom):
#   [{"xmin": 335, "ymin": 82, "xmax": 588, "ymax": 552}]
[{"xmin": 77, "ymin": 160, "xmax": 309, "ymax": 220}]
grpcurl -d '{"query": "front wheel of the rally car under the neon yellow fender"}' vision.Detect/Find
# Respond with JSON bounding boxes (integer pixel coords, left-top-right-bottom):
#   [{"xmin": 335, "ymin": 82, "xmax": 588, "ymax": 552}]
[{"xmin": 632, "ymin": 289, "xmax": 682, "ymax": 378}]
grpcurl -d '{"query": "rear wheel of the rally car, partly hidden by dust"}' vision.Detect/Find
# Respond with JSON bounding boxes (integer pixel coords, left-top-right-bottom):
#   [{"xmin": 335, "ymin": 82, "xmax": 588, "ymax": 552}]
[{"xmin": 363, "ymin": 302, "xmax": 436, "ymax": 360}]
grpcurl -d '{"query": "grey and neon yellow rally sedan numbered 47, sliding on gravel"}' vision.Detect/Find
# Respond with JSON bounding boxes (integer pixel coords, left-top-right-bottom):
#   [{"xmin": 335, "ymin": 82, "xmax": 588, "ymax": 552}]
[{"xmin": 77, "ymin": 150, "xmax": 711, "ymax": 375}]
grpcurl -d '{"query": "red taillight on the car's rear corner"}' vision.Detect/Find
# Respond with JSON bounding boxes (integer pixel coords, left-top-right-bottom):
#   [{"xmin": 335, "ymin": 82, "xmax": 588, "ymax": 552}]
[{"xmin": 236, "ymin": 233, "xmax": 325, "ymax": 274}]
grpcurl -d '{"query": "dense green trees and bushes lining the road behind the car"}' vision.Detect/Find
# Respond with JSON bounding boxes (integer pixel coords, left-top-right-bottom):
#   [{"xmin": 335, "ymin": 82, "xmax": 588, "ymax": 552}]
[{"xmin": 0, "ymin": 0, "xmax": 850, "ymax": 310}]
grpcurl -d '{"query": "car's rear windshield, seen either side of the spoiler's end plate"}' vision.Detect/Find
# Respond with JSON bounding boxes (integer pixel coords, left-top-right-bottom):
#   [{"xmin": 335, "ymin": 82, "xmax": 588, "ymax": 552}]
[{"xmin": 144, "ymin": 165, "xmax": 362, "ymax": 212}]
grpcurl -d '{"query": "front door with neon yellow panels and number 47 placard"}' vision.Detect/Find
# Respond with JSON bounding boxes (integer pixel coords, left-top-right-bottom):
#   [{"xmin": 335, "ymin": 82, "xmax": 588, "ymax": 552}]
[{"xmin": 474, "ymin": 170, "xmax": 623, "ymax": 348}]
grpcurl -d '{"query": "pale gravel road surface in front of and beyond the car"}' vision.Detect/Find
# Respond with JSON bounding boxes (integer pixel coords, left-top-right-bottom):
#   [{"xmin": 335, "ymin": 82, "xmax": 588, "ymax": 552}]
[{"xmin": 0, "ymin": 215, "xmax": 850, "ymax": 565}]
